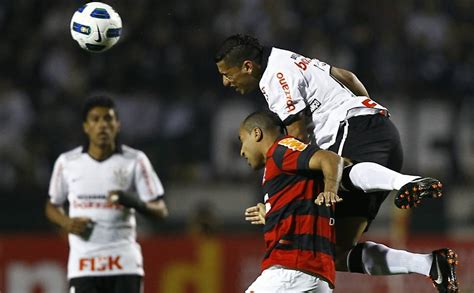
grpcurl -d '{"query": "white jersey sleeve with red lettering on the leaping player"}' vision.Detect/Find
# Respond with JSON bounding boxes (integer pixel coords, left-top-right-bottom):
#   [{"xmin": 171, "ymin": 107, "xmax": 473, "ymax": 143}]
[{"xmin": 260, "ymin": 65, "xmax": 306, "ymax": 122}]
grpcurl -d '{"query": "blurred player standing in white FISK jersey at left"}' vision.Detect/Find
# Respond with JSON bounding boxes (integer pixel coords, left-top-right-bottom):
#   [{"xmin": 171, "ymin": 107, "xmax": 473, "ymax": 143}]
[{"xmin": 45, "ymin": 96, "xmax": 168, "ymax": 293}]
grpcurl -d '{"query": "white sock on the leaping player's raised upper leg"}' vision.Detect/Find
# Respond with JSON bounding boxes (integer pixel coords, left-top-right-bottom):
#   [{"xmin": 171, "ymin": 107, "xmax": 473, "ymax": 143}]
[{"xmin": 349, "ymin": 162, "xmax": 420, "ymax": 192}]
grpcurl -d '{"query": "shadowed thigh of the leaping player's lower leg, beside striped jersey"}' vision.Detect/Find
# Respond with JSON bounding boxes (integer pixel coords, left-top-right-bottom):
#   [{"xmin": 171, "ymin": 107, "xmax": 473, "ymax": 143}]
[{"xmin": 336, "ymin": 217, "xmax": 368, "ymax": 272}]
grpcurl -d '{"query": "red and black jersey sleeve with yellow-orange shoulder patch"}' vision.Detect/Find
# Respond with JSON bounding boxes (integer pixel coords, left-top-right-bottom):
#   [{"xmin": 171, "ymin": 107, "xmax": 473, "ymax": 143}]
[{"xmin": 273, "ymin": 137, "xmax": 320, "ymax": 174}]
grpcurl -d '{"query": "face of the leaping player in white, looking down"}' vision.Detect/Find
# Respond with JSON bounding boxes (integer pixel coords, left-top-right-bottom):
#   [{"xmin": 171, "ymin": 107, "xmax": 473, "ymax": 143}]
[{"xmin": 216, "ymin": 60, "xmax": 259, "ymax": 95}]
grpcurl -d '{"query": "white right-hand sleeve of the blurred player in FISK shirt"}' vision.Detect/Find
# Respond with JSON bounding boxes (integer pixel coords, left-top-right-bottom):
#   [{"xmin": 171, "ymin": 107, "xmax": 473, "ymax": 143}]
[{"xmin": 134, "ymin": 152, "xmax": 164, "ymax": 201}]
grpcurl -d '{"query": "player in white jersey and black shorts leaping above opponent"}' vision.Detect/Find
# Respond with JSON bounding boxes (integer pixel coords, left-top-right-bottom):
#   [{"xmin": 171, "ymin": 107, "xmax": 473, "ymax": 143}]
[{"xmin": 215, "ymin": 35, "xmax": 457, "ymax": 292}]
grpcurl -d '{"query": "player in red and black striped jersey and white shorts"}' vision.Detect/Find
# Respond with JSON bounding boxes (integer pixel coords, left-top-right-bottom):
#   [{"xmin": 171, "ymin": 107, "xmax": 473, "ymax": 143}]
[{"xmin": 239, "ymin": 112, "xmax": 343, "ymax": 293}]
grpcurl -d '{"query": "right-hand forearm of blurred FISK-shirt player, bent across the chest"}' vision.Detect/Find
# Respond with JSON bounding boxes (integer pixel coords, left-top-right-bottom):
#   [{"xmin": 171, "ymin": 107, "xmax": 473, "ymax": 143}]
[{"xmin": 107, "ymin": 190, "xmax": 168, "ymax": 219}]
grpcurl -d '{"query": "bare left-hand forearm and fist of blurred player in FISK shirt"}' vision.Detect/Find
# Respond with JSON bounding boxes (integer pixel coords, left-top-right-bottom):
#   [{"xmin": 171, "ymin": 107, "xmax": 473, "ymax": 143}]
[{"xmin": 45, "ymin": 200, "xmax": 93, "ymax": 238}]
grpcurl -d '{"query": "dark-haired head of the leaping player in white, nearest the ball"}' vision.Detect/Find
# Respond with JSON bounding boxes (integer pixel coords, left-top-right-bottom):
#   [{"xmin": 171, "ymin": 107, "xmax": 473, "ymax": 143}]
[{"xmin": 215, "ymin": 34, "xmax": 263, "ymax": 94}]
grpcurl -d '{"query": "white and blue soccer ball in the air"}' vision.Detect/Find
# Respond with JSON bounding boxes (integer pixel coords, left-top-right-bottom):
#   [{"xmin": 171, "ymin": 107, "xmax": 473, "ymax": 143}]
[{"xmin": 70, "ymin": 2, "xmax": 122, "ymax": 53}]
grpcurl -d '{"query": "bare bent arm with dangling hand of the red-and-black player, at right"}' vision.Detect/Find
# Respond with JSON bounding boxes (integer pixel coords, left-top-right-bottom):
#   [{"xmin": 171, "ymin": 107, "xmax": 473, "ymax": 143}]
[{"xmin": 309, "ymin": 150, "xmax": 344, "ymax": 206}]
